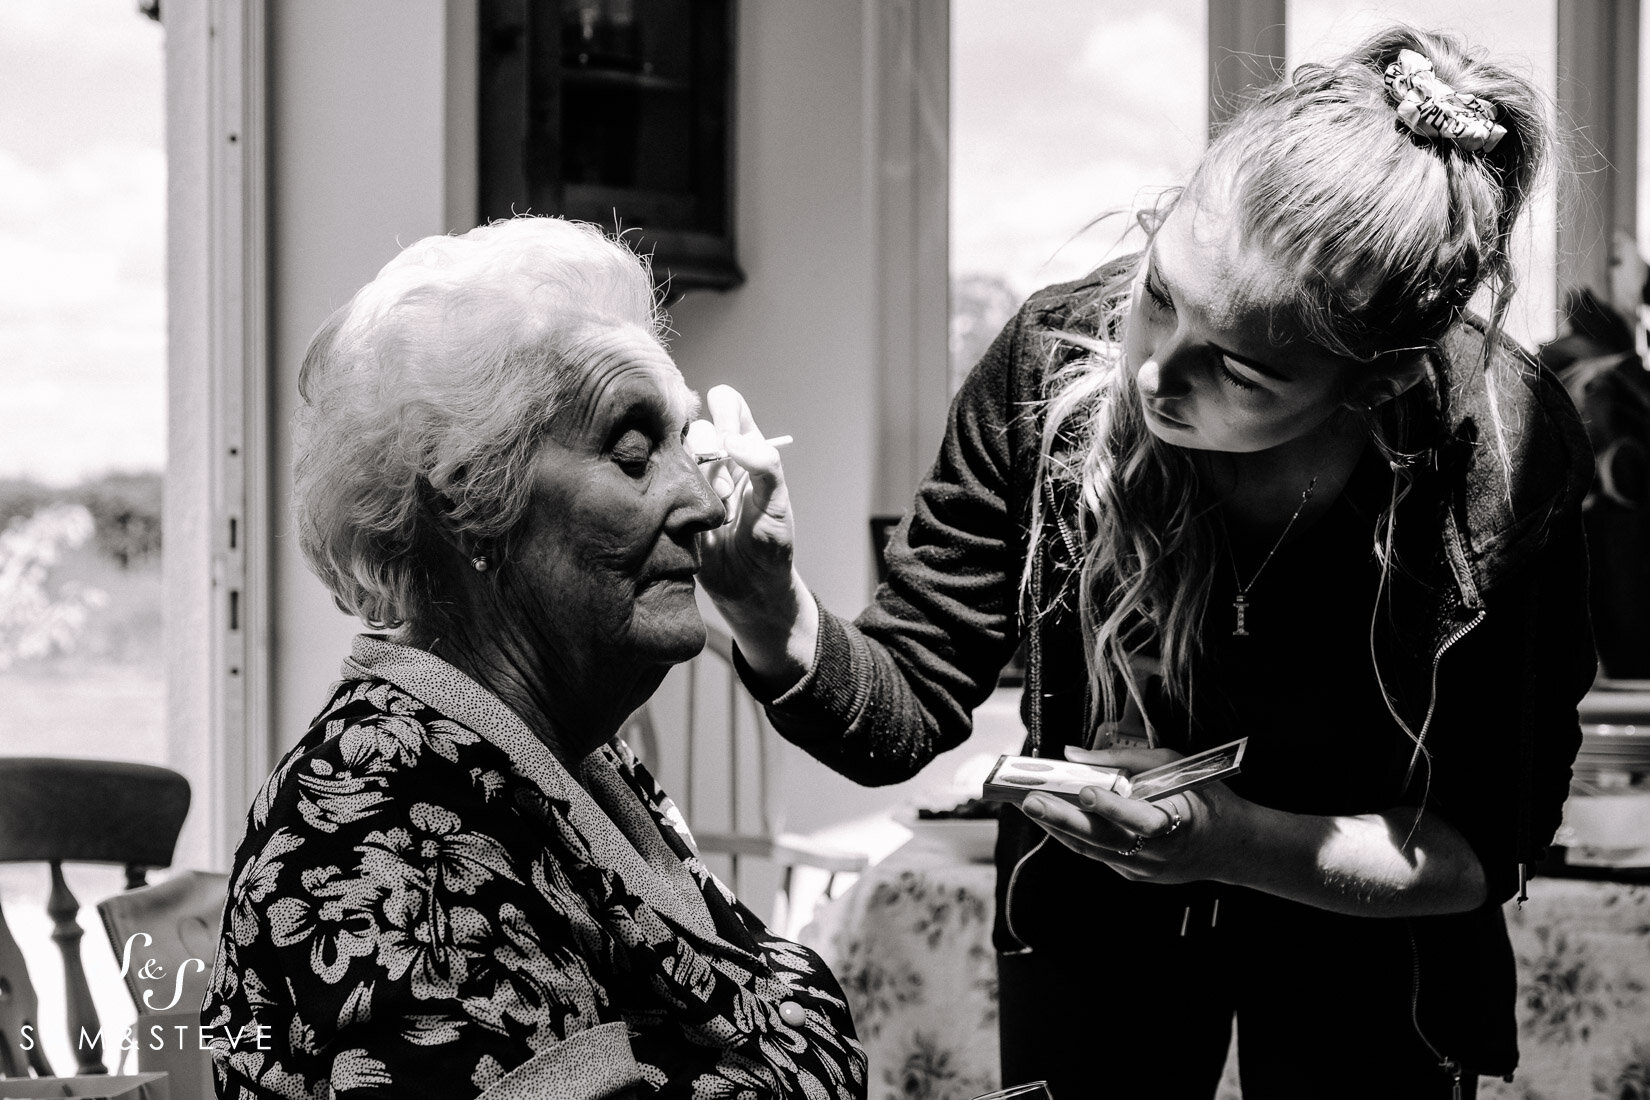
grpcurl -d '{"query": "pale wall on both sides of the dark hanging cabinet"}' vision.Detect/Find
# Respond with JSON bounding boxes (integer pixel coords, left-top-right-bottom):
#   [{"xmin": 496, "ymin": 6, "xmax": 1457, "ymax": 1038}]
[{"xmin": 269, "ymin": 0, "xmax": 944, "ymax": 850}]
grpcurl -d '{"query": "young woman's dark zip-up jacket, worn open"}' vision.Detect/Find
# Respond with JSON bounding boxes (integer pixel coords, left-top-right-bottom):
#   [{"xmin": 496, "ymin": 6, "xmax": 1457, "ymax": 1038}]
[{"xmin": 755, "ymin": 267, "xmax": 1596, "ymax": 1074}]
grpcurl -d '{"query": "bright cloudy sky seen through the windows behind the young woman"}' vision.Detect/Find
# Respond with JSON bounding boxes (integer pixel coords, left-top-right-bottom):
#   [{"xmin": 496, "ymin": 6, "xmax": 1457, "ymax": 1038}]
[{"xmin": 950, "ymin": 0, "xmax": 1556, "ymax": 347}]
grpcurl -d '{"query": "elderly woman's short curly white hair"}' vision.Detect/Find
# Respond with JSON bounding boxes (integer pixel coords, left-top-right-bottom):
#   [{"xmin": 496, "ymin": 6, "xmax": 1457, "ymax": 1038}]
[{"xmin": 294, "ymin": 218, "xmax": 662, "ymax": 627}]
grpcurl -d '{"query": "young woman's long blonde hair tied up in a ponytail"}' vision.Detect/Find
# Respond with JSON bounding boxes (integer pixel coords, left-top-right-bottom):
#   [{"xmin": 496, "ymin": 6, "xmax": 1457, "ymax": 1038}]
[{"xmin": 1028, "ymin": 28, "xmax": 1551, "ymax": 722}]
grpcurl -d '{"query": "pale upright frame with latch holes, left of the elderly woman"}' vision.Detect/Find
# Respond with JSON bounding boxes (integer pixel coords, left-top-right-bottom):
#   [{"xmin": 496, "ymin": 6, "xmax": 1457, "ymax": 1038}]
[{"xmin": 162, "ymin": 0, "xmax": 274, "ymax": 867}]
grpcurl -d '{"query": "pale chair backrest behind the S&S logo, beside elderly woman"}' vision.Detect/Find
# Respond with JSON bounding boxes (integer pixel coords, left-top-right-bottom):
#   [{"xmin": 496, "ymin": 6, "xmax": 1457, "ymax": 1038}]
[{"xmin": 97, "ymin": 871, "xmax": 229, "ymax": 1013}]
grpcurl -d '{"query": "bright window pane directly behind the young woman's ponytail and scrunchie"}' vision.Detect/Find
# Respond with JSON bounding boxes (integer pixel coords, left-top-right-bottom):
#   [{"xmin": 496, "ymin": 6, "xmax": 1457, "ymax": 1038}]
[{"xmin": 1287, "ymin": 0, "xmax": 1558, "ymax": 348}]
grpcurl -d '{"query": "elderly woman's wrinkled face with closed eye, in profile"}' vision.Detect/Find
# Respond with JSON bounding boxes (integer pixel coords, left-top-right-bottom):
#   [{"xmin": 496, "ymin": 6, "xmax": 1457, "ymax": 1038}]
[{"xmin": 500, "ymin": 327, "xmax": 723, "ymax": 676}]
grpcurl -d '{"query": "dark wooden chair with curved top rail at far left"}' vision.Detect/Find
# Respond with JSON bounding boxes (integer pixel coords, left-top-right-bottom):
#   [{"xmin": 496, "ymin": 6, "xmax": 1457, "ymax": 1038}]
[{"xmin": 0, "ymin": 757, "xmax": 190, "ymax": 1077}]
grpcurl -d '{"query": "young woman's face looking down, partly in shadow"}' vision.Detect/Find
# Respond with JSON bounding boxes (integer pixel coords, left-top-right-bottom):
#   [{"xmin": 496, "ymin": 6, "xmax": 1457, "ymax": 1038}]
[{"xmin": 1124, "ymin": 186, "xmax": 1363, "ymax": 452}]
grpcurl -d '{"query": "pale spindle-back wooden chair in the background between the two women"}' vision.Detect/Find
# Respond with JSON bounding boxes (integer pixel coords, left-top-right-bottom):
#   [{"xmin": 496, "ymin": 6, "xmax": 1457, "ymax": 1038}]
[{"xmin": 627, "ymin": 625, "xmax": 871, "ymax": 927}]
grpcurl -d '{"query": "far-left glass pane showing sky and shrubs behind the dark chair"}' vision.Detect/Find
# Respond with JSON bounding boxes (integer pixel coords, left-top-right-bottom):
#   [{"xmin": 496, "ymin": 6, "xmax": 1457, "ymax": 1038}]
[{"xmin": 0, "ymin": 0, "xmax": 165, "ymax": 1074}]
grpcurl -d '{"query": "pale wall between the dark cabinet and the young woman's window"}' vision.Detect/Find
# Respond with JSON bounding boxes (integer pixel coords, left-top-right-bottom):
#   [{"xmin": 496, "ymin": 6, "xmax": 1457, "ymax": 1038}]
[{"xmin": 655, "ymin": 0, "xmax": 944, "ymax": 831}]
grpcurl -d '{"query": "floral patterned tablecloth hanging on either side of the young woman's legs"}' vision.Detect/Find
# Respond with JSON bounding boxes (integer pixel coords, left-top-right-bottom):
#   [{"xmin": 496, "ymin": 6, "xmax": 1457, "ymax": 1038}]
[{"xmin": 802, "ymin": 841, "xmax": 1650, "ymax": 1100}]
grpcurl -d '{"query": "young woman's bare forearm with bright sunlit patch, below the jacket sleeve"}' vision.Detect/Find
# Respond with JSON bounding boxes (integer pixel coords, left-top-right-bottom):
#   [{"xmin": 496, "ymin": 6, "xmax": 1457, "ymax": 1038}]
[{"xmin": 1221, "ymin": 803, "xmax": 1485, "ymax": 917}]
